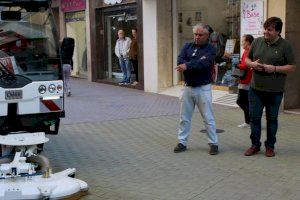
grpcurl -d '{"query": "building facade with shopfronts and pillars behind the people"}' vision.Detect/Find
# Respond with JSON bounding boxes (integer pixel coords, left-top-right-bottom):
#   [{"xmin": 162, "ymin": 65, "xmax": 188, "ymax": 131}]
[{"xmin": 53, "ymin": 0, "xmax": 300, "ymax": 109}]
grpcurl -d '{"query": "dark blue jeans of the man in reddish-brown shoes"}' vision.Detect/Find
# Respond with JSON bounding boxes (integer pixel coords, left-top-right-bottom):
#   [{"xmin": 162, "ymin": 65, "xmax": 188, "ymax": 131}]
[{"xmin": 249, "ymin": 88, "xmax": 283, "ymax": 149}]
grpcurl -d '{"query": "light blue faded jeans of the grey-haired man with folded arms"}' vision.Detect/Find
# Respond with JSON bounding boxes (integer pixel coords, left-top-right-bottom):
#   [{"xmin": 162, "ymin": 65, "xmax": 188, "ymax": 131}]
[{"xmin": 178, "ymin": 84, "xmax": 218, "ymax": 146}]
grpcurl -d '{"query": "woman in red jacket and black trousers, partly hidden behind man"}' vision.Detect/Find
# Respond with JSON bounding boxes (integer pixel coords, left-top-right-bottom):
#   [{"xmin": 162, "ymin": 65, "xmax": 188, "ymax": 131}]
[{"xmin": 236, "ymin": 35, "xmax": 254, "ymax": 128}]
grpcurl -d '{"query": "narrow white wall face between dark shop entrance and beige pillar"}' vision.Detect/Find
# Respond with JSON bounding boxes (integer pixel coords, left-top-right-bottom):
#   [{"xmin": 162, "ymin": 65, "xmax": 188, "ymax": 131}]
[{"xmin": 143, "ymin": 0, "xmax": 158, "ymax": 93}]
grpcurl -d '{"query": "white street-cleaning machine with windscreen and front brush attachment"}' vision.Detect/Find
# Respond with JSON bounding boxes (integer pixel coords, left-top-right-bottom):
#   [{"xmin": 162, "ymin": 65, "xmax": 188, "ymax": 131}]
[{"xmin": 0, "ymin": 0, "xmax": 88, "ymax": 200}]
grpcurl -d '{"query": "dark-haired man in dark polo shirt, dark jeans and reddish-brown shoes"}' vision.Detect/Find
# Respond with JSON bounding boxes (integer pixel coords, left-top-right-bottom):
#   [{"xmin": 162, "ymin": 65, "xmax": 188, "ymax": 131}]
[{"xmin": 244, "ymin": 17, "xmax": 296, "ymax": 157}]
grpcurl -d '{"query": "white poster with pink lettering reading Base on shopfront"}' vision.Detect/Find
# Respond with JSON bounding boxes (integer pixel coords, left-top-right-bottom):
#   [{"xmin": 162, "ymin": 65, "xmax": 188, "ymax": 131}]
[{"xmin": 241, "ymin": 0, "xmax": 265, "ymax": 37}]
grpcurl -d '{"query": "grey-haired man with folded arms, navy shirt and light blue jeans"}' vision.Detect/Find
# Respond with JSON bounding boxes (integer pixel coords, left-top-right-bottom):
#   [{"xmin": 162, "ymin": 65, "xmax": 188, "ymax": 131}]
[{"xmin": 174, "ymin": 24, "xmax": 219, "ymax": 155}]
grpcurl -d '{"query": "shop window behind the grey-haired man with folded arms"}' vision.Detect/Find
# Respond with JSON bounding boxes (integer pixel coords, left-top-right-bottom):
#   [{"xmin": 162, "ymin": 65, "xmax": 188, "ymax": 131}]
[{"xmin": 177, "ymin": 0, "xmax": 241, "ymax": 86}]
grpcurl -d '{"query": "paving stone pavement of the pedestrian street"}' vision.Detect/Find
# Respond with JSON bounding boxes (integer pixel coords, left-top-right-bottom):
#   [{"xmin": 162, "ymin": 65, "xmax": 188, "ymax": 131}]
[{"xmin": 45, "ymin": 79, "xmax": 300, "ymax": 200}]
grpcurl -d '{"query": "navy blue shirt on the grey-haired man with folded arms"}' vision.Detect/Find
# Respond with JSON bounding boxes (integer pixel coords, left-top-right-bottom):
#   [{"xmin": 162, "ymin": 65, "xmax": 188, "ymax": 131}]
[{"xmin": 177, "ymin": 43, "xmax": 216, "ymax": 87}]
